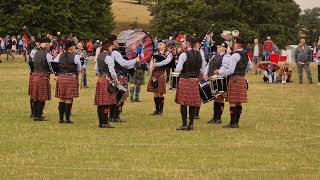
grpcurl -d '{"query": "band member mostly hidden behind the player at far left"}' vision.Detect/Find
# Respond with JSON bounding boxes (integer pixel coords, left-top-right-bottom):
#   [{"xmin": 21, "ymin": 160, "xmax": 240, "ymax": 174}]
[{"xmin": 28, "ymin": 37, "xmax": 40, "ymax": 118}]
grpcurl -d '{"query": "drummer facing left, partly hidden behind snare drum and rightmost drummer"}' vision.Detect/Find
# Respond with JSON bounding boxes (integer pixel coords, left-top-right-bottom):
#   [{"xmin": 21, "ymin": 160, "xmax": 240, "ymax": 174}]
[{"xmin": 205, "ymin": 38, "xmax": 232, "ymax": 124}]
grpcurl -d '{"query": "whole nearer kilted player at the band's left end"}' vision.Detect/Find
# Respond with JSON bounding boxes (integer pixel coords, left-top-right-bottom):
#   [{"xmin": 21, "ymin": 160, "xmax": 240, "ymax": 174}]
[{"xmin": 30, "ymin": 38, "xmax": 53, "ymax": 121}]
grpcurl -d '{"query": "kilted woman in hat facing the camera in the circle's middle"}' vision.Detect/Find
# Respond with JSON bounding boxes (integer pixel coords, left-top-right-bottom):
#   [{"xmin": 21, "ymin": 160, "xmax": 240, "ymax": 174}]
[{"xmin": 147, "ymin": 40, "xmax": 172, "ymax": 116}]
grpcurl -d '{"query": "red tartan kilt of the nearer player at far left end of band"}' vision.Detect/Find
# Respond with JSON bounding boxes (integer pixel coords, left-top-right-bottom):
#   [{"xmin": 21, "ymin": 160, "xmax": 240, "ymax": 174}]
[{"xmin": 29, "ymin": 72, "xmax": 51, "ymax": 102}]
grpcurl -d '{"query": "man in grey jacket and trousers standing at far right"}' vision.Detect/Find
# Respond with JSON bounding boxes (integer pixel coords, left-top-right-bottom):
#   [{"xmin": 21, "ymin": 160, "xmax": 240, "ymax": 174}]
[{"xmin": 294, "ymin": 38, "xmax": 313, "ymax": 84}]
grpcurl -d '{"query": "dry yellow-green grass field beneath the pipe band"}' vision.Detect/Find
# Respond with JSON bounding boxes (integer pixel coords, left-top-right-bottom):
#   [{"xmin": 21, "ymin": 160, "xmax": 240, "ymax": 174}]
[{"xmin": 0, "ymin": 56, "xmax": 320, "ymax": 180}]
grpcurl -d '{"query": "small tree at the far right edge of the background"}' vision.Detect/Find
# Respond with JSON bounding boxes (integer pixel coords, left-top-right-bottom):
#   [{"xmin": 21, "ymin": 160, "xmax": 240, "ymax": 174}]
[{"xmin": 299, "ymin": 8, "xmax": 320, "ymax": 45}]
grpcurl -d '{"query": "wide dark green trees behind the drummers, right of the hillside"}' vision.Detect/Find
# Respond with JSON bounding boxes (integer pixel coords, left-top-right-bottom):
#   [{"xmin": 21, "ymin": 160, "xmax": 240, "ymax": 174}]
[{"xmin": 153, "ymin": 0, "xmax": 301, "ymax": 47}]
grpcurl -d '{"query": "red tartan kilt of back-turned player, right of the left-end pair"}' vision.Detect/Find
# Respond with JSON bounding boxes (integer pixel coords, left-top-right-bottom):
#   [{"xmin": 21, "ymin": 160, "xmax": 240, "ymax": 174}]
[{"xmin": 56, "ymin": 74, "xmax": 79, "ymax": 99}]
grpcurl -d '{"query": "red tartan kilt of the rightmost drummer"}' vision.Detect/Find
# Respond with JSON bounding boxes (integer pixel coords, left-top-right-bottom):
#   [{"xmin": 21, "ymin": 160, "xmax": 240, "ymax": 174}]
[{"xmin": 226, "ymin": 76, "xmax": 248, "ymax": 104}]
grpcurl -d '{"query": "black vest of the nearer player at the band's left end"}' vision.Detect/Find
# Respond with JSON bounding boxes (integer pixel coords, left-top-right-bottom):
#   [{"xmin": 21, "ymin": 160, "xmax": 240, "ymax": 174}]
[{"xmin": 33, "ymin": 48, "xmax": 50, "ymax": 73}]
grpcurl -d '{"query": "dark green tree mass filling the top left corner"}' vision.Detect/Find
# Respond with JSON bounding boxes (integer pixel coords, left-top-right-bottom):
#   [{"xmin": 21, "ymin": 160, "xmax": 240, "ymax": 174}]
[{"xmin": 0, "ymin": 0, "xmax": 114, "ymax": 39}]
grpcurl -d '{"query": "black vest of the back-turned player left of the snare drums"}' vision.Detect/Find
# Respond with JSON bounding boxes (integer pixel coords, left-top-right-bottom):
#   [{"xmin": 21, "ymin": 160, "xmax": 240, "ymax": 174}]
[{"xmin": 180, "ymin": 49, "xmax": 202, "ymax": 78}]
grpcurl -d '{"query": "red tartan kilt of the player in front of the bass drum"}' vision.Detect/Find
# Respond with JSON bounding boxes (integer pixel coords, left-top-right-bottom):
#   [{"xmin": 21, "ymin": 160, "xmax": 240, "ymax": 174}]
[{"xmin": 94, "ymin": 76, "xmax": 116, "ymax": 106}]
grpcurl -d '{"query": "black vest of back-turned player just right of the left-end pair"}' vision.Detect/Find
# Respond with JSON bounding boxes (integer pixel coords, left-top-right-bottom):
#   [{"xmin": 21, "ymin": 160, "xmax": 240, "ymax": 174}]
[{"xmin": 59, "ymin": 52, "xmax": 78, "ymax": 74}]
